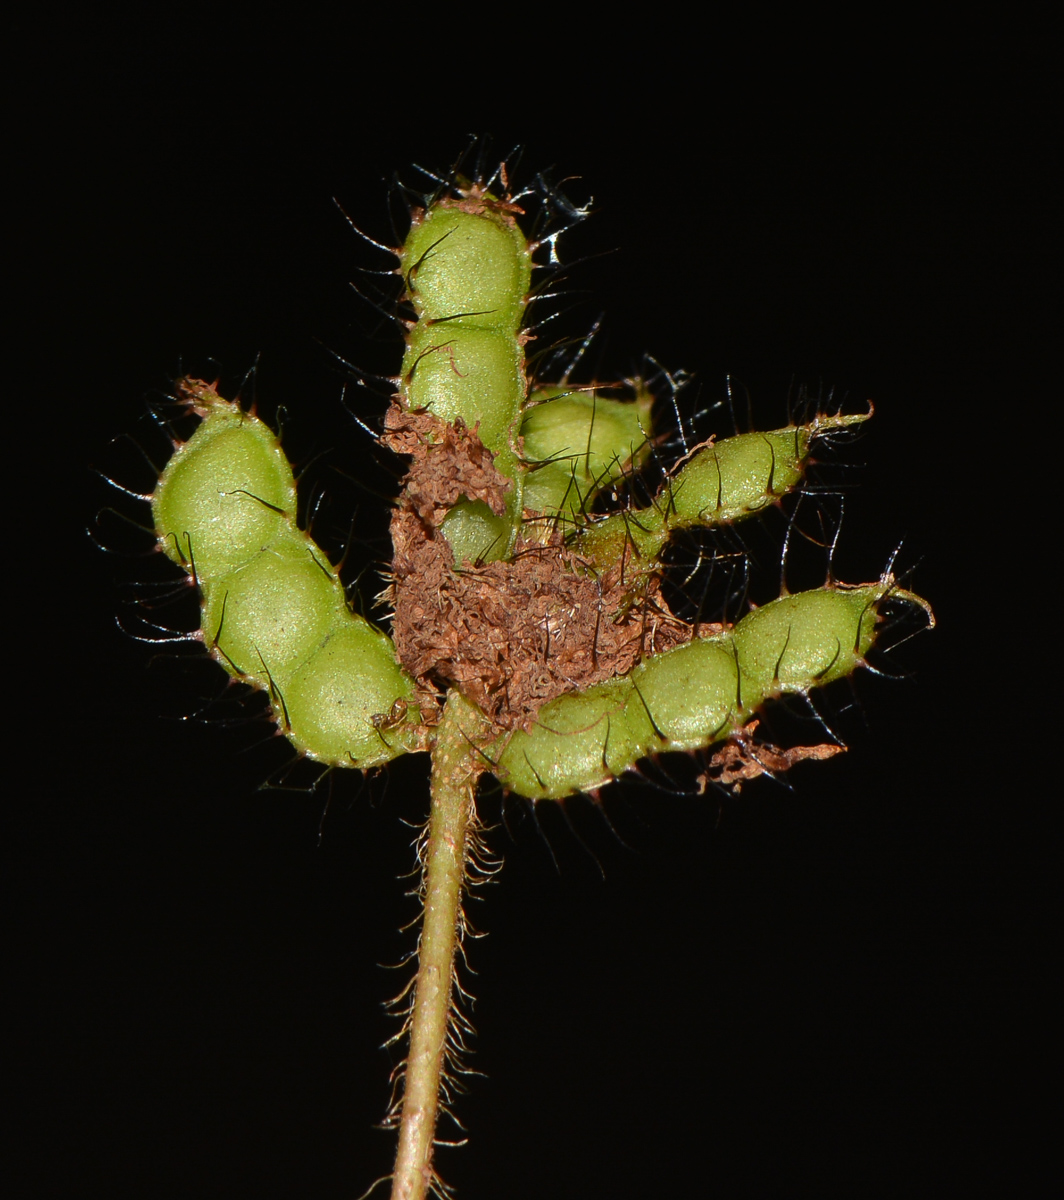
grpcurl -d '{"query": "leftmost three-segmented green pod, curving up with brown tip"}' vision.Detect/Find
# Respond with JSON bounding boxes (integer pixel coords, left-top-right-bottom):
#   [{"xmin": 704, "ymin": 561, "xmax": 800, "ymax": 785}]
[{"xmin": 151, "ymin": 380, "xmax": 420, "ymax": 767}]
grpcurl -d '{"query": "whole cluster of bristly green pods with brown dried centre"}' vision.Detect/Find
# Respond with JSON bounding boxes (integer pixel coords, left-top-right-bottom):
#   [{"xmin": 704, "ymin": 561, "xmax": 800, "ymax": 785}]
[{"xmin": 152, "ymin": 171, "xmax": 930, "ymax": 799}]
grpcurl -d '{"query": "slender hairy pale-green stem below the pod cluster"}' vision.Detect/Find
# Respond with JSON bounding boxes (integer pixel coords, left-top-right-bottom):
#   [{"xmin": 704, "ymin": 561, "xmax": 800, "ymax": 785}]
[{"xmin": 391, "ymin": 691, "xmax": 487, "ymax": 1200}]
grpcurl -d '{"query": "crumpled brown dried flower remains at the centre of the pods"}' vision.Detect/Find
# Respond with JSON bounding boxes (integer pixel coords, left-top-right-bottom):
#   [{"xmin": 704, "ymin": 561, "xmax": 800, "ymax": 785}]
[{"xmin": 384, "ymin": 406, "xmax": 692, "ymax": 728}]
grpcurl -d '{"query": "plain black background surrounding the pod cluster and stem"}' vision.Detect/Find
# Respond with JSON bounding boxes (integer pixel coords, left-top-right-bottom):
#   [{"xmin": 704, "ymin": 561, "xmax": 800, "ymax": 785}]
[{"xmin": 5, "ymin": 18, "xmax": 1059, "ymax": 1200}]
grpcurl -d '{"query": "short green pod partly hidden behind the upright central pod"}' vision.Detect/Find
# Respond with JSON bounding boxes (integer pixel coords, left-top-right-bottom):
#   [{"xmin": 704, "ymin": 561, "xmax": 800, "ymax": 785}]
[{"xmin": 521, "ymin": 384, "xmax": 654, "ymax": 518}]
